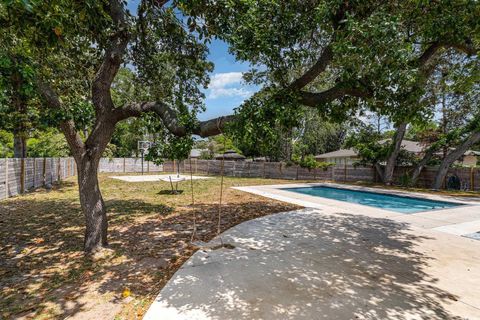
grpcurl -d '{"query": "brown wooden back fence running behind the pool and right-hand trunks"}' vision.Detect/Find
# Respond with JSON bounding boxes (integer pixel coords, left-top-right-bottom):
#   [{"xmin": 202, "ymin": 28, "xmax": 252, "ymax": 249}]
[{"xmin": 163, "ymin": 159, "xmax": 480, "ymax": 191}]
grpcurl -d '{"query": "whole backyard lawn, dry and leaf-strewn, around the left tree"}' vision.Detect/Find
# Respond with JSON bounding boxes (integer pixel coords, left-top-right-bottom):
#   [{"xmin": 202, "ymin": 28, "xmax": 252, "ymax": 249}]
[{"xmin": 0, "ymin": 175, "xmax": 297, "ymax": 319}]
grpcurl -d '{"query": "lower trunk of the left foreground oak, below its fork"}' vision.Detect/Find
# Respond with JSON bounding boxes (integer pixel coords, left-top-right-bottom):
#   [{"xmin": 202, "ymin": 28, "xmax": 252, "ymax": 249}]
[{"xmin": 77, "ymin": 155, "xmax": 108, "ymax": 253}]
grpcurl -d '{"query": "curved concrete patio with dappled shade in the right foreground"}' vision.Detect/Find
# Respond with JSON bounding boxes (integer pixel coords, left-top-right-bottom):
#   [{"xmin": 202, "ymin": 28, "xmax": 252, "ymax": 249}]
[{"xmin": 144, "ymin": 209, "xmax": 480, "ymax": 320}]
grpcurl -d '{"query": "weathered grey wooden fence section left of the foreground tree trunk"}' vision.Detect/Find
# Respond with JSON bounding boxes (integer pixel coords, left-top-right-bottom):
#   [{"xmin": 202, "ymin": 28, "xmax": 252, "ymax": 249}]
[{"xmin": 0, "ymin": 158, "xmax": 77, "ymax": 200}]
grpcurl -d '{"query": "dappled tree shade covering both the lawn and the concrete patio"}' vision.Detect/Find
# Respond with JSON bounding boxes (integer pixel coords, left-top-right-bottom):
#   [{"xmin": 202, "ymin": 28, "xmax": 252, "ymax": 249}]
[{"xmin": 0, "ymin": 186, "xmax": 468, "ymax": 319}]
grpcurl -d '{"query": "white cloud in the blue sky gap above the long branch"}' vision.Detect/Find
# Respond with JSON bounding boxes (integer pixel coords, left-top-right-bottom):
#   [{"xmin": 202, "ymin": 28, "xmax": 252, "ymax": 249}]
[{"xmin": 208, "ymin": 72, "xmax": 253, "ymax": 99}]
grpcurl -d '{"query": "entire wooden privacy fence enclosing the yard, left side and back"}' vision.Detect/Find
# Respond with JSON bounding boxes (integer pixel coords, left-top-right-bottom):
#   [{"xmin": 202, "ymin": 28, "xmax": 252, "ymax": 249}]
[{"xmin": 0, "ymin": 158, "xmax": 480, "ymax": 200}]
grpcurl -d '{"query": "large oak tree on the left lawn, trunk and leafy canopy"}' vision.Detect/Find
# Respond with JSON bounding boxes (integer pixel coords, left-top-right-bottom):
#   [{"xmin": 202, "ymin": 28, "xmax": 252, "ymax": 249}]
[{"xmin": 0, "ymin": 0, "xmax": 232, "ymax": 253}]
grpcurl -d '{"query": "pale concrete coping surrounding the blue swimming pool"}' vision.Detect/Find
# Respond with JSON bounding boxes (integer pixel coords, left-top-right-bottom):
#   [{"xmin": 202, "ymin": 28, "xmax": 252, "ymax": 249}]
[{"xmin": 232, "ymin": 182, "xmax": 480, "ymax": 241}]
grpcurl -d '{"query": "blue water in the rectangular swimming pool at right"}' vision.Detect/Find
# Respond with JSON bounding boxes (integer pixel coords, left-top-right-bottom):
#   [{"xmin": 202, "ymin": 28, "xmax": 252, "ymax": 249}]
[{"xmin": 284, "ymin": 187, "xmax": 462, "ymax": 213}]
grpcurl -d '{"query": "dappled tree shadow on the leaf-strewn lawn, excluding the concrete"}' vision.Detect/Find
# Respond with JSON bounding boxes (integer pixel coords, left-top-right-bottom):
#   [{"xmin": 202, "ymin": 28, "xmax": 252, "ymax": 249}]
[{"xmin": 0, "ymin": 197, "xmax": 289, "ymax": 319}]
